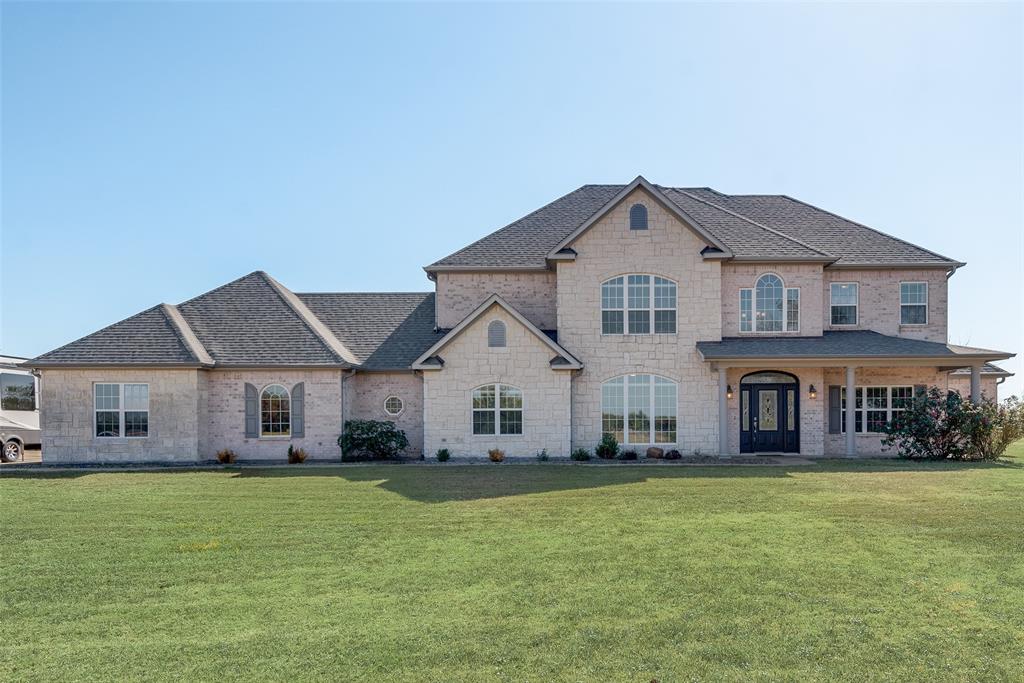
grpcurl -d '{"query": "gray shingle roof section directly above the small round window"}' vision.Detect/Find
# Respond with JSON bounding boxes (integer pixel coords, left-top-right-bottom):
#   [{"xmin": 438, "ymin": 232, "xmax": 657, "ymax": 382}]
[{"xmin": 296, "ymin": 292, "xmax": 444, "ymax": 370}]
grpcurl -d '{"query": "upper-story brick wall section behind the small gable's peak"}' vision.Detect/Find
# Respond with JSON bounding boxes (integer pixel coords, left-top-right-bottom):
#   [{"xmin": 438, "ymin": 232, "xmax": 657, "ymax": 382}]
[{"xmin": 434, "ymin": 271, "xmax": 557, "ymax": 330}]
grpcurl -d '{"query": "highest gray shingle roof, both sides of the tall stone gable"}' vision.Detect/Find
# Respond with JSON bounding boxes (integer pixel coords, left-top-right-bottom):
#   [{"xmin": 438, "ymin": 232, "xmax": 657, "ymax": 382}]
[{"xmin": 427, "ymin": 185, "xmax": 958, "ymax": 270}]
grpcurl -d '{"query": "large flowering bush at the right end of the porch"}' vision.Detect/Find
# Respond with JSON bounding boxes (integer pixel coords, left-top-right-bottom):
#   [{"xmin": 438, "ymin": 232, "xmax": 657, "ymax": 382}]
[{"xmin": 882, "ymin": 387, "xmax": 1024, "ymax": 460}]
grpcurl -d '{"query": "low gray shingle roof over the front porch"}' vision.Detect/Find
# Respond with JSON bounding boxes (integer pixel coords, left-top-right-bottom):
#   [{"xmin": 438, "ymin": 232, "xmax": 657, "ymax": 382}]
[{"xmin": 697, "ymin": 330, "xmax": 1013, "ymax": 360}]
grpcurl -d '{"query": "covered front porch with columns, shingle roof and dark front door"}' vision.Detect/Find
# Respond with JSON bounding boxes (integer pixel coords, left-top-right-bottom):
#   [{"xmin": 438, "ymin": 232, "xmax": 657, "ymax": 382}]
[{"xmin": 697, "ymin": 331, "xmax": 1013, "ymax": 457}]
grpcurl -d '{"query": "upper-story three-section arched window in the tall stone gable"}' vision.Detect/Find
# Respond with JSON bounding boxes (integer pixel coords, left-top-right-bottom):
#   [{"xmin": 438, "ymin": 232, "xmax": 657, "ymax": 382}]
[{"xmin": 601, "ymin": 275, "xmax": 676, "ymax": 335}]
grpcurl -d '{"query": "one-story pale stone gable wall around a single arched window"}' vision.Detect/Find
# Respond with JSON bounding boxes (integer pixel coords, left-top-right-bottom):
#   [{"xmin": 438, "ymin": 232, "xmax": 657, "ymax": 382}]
[{"xmin": 423, "ymin": 304, "xmax": 571, "ymax": 458}]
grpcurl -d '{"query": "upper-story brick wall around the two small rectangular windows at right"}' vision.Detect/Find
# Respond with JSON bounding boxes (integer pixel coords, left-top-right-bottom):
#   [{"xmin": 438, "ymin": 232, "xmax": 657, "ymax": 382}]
[{"xmin": 822, "ymin": 268, "xmax": 948, "ymax": 343}]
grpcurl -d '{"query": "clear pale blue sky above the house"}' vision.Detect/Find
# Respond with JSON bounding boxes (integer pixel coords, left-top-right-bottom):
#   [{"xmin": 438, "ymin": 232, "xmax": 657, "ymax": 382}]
[{"xmin": 0, "ymin": 2, "xmax": 1024, "ymax": 392}]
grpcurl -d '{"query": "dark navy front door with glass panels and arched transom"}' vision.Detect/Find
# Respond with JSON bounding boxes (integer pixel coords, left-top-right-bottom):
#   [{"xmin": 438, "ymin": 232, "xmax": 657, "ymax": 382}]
[{"xmin": 739, "ymin": 372, "xmax": 800, "ymax": 453}]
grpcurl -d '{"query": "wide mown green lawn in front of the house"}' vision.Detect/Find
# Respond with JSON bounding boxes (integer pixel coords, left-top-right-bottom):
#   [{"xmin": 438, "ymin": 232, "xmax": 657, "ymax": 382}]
[{"xmin": 0, "ymin": 443, "xmax": 1024, "ymax": 683}]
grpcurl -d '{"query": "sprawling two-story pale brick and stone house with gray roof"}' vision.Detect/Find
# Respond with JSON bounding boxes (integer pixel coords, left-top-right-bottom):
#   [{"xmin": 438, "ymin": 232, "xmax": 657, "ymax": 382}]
[{"xmin": 28, "ymin": 178, "xmax": 1013, "ymax": 461}]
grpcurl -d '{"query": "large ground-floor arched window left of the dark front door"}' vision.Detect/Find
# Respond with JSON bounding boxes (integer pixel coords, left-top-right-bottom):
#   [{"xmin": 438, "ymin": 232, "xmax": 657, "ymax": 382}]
[{"xmin": 601, "ymin": 375, "xmax": 677, "ymax": 444}]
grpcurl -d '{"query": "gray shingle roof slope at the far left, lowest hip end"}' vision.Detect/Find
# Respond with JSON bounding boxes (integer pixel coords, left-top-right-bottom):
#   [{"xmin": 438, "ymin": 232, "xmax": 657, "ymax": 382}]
[{"xmin": 26, "ymin": 305, "xmax": 201, "ymax": 367}]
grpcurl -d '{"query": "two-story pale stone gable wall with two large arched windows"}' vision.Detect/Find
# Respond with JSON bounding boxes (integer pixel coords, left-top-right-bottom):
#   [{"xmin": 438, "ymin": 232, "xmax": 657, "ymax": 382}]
[{"xmin": 557, "ymin": 189, "xmax": 722, "ymax": 453}]
